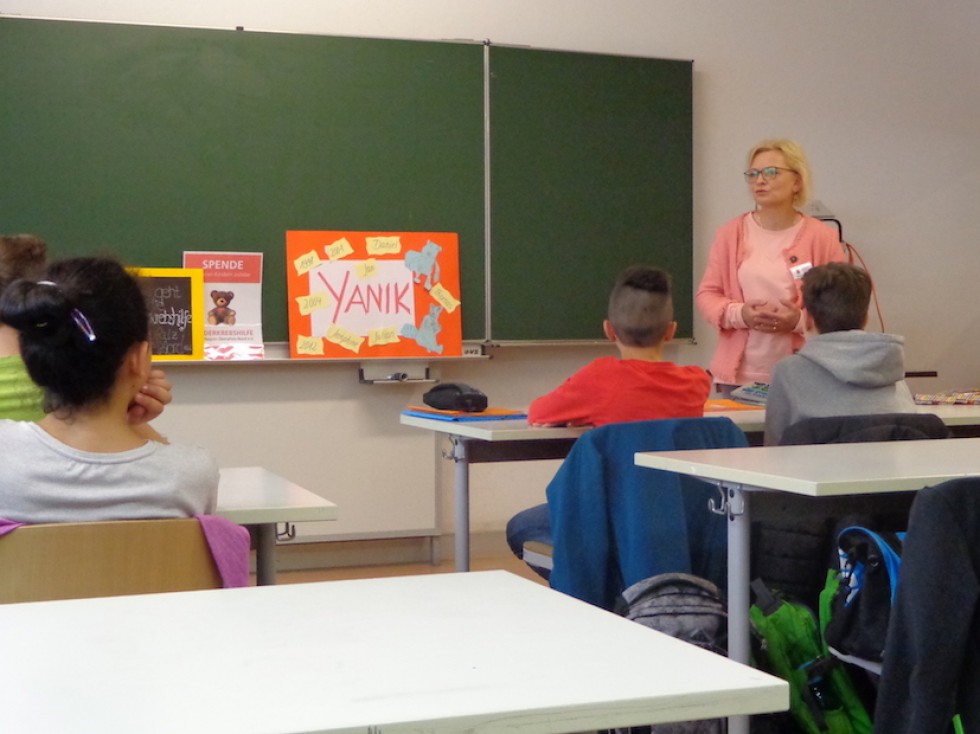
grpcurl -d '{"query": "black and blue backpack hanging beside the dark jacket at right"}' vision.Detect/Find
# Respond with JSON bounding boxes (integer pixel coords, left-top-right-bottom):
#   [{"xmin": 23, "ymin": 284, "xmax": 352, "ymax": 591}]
[{"xmin": 824, "ymin": 526, "xmax": 905, "ymax": 673}]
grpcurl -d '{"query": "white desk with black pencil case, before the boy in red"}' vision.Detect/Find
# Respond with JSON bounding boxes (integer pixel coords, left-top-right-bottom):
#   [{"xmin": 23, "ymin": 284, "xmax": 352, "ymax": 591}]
[{"xmin": 401, "ymin": 415, "xmax": 588, "ymax": 571}]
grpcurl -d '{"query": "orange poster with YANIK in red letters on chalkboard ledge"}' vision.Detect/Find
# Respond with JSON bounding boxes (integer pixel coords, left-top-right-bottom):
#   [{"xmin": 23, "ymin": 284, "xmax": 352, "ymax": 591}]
[{"xmin": 286, "ymin": 231, "xmax": 462, "ymax": 359}]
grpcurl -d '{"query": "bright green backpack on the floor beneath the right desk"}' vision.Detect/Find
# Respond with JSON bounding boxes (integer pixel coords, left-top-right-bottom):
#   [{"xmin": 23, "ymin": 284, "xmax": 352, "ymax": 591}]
[{"xmin": 749, "ymin": 580, "xmax": 871, "ymax": 734}]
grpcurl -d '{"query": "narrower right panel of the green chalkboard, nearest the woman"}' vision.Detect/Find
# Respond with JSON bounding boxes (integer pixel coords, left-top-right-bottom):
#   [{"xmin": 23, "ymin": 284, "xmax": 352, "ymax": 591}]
[{"xmin": 490, "ymin": 47, "xmax": 693, "ymax": 341}]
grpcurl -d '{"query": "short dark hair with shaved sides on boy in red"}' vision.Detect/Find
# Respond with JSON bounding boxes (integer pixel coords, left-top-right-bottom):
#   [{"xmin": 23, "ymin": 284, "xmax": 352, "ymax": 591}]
[{"xmin": 608, "ymin": 265, "xmax": 674, "ymax": 347}]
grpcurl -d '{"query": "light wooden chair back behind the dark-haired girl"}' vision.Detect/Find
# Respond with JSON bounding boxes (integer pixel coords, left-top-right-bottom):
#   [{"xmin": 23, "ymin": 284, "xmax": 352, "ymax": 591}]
[{"xmin": 0, "ymin": 518, "xmax": 221, "ymax": 604}]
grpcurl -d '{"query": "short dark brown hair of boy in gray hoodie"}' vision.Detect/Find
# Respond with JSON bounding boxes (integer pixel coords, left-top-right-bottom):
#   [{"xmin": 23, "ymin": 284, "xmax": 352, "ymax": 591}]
[{"xmin": 803, "ymin": 262, "xmax": 871, "ymax": 334}]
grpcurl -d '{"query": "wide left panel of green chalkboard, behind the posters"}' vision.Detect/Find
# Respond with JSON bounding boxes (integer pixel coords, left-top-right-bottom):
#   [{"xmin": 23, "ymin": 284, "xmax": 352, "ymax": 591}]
[{"xmin": 0, "ymin": 18, "xmax": 485, "ymax": 341}]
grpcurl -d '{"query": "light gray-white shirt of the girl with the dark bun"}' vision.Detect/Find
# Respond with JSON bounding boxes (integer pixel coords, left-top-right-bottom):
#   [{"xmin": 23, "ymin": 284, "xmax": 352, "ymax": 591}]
[{"xmin": 0, "ymin": 420, "xmax": 218, "ymax": 523}]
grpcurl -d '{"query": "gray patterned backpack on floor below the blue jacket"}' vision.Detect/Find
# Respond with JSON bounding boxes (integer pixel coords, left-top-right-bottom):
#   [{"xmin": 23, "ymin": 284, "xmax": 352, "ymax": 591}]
[{"xmin": 613, "ymin": 573, "xmax": 728, "ymax": 734}]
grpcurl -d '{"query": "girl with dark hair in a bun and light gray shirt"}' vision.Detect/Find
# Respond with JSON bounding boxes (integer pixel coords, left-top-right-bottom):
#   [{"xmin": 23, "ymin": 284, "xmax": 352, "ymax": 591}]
[{"xmin": 0, "ymin": 258, "xmax": 218, "ymax": 522}]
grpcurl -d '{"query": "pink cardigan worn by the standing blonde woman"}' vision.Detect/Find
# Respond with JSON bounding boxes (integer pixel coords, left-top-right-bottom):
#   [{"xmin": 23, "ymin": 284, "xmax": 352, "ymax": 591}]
[{"xmin": 694, "ymin": 214, "xmax": 846, "ymax": 385}]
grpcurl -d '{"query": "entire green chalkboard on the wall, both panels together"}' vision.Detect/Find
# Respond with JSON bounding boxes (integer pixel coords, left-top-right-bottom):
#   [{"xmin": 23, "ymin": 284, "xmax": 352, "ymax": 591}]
[{"xmin": 0, "ymin": 18, "xmax": 693, "ymax": 342}]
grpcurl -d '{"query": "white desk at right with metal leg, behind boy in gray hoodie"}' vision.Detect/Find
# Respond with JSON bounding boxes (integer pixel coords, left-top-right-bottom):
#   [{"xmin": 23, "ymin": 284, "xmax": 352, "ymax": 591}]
[{"xmin": 636, "ymin": 438, "xmax": 980, "ymax": 734}]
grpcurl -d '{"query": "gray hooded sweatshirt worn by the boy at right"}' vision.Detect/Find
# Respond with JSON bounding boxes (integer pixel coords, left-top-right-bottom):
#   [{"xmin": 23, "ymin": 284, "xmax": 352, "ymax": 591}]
[{"xmin": 765, "ymin": 330, "xmax": 918, "ymax": 446}]
